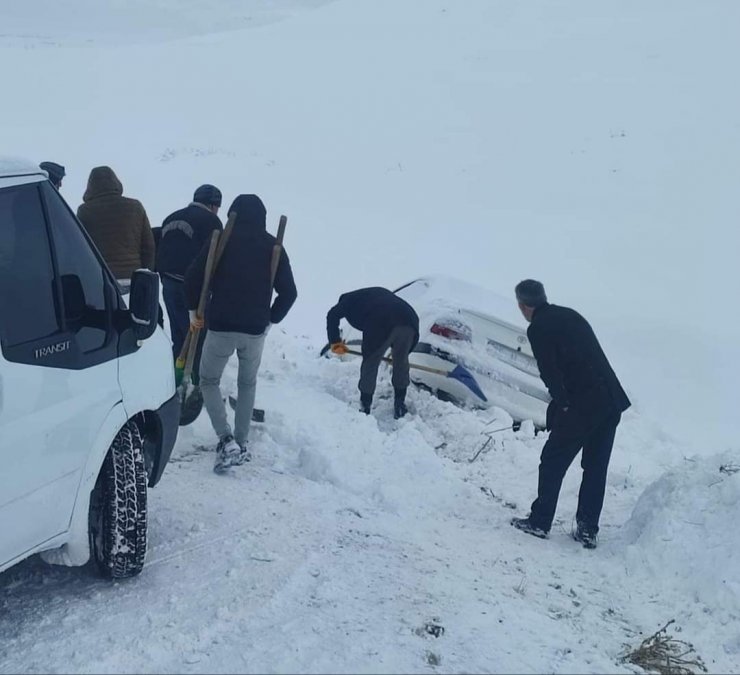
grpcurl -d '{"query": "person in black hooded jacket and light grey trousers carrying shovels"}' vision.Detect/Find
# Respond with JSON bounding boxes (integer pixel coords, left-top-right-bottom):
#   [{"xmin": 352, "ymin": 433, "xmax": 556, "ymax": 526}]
[{"xmin": 185, "ymin": 195, "xmax": 298, "ymax": 472}]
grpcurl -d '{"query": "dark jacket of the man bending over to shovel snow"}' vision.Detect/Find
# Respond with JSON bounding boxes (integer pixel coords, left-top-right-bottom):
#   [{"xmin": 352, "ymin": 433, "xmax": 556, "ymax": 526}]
[{"xmin": 326, "ymin": 286, "xmax": 419, "ymax": 354}]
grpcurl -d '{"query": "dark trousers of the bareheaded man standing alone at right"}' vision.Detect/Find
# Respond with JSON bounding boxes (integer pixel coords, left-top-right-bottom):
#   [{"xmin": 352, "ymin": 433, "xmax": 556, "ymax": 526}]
[{"xmin": 530, "ymin": 411, "xmax": 621, "ymax": 534}]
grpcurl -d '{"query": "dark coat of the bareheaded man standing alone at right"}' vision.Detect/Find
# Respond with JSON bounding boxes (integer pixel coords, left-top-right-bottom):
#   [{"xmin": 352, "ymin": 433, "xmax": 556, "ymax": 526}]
[{"xmin": 527, "ymin": 304, "xmax": 630, "ymax": 428}]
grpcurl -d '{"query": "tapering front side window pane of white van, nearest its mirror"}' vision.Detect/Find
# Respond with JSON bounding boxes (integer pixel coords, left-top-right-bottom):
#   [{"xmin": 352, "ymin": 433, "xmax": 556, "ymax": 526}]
[{"xmin": 41, "ymin": 181, "xmax": 109, "ymax": 354}]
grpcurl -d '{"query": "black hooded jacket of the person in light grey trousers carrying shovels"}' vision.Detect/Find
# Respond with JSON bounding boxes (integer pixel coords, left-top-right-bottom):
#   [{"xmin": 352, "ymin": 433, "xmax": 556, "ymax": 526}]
[{"xmin": 185, "ymin": 195, "xmax": 298, "ymax": 335}]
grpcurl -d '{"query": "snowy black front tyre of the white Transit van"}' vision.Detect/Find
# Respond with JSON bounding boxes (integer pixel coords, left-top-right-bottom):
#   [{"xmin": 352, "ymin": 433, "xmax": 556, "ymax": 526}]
[{"xmin": 90, "ymin": 422, "xmax": 147, "ymax": 579}]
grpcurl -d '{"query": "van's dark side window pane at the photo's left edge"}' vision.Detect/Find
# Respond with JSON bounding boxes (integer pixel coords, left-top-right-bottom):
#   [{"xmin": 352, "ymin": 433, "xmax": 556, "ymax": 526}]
[{"xmin": 0, "ymin": 183, "xmax": 61, "ymax": 347}]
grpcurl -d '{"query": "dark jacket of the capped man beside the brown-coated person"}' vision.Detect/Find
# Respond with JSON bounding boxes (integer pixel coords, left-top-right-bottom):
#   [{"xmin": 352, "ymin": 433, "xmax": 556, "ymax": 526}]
[{"xmin": 157, "ymin": 202, "xmax": 223, "ymax": 279}]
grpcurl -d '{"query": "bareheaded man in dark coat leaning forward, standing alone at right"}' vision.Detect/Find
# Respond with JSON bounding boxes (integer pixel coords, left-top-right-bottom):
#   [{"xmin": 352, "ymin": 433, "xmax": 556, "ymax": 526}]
[{"xmin": 511, "ymin": 279, "xmax": 630, "ymax": 548}]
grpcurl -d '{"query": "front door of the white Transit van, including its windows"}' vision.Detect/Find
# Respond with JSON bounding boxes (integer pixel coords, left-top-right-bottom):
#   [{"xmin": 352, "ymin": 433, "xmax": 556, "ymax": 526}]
[{"xmin": 0, "ymin": 181, "xmax": 121, "ymax": 565}]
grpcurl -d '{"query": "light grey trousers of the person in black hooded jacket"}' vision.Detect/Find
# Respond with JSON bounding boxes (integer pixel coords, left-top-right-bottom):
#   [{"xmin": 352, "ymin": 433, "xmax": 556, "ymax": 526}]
[{"xmin": 200, "ymin": 330, "xmax": 267, "ymax": 445}]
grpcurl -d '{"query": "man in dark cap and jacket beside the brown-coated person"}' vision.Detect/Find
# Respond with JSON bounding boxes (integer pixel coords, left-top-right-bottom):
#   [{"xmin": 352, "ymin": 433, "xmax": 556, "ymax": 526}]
[{"xmin": 156, "ymin": 185, "xmax": 222, "ymax": 386}]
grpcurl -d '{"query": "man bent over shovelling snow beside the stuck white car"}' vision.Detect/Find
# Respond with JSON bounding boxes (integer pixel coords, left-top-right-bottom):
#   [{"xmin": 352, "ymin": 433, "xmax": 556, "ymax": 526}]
[{"xmin": 326, "ymin": 287, "xmax": 419, "ymax": 419}]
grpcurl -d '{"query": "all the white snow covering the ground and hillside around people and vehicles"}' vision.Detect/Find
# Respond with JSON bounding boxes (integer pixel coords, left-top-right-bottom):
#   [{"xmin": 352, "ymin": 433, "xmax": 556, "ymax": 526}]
[{"xmin": 0, "ymin": 0, "xmax": 740, "ymax": 673}]
